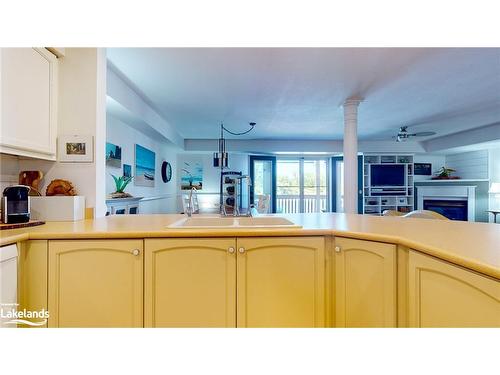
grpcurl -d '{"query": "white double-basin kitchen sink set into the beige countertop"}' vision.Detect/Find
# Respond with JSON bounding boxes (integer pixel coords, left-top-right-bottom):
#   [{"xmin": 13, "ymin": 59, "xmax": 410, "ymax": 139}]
[{"xmin": 168, "ymin": 216, "xmax": 302, "ymax": 229}]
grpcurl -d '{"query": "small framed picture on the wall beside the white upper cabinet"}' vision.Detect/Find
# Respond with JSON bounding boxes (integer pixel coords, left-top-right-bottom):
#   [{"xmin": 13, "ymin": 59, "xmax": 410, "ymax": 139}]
[{"xmin": 57, "ymin": 135, "xmax": 94, "ymax": 163}]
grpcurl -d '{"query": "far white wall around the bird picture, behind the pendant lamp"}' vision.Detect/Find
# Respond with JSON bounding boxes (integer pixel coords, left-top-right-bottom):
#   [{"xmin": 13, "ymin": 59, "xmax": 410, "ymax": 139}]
[{"xmin": 177, "ymin": 150, "xmax": 249, "ymax": 212}]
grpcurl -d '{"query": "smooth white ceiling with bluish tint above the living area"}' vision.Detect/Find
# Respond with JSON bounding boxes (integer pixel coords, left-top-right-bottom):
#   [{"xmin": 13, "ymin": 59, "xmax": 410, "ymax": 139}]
[{"xmin": 107, "ymin": 48, "xmax": 500, "ymax": 140}]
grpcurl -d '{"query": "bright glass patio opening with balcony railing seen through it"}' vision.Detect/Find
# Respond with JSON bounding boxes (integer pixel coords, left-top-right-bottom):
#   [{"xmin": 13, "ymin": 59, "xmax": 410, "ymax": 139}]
[{"xmin": 276, "ymin": 158, "xmax": 328, "ymax": 213}]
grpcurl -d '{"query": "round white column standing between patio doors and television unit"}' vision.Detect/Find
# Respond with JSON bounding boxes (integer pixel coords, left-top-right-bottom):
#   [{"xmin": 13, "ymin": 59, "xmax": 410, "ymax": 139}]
[{"xmin": 344, "ymin": 98, "xmax": 362, "ymax": 214}]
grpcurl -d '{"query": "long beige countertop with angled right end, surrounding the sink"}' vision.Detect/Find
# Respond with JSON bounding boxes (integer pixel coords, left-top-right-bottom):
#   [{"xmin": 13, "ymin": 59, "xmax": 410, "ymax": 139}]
[{"xmin": 0, "ymin": 213, "xmax": 500, "ymax": 279}]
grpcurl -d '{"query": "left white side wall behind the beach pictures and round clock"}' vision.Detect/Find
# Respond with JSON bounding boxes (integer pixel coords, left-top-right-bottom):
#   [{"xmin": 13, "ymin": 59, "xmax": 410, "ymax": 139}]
[{"xmin": 106, "ymin": 115, "xmax": 178, "ymax": 214}]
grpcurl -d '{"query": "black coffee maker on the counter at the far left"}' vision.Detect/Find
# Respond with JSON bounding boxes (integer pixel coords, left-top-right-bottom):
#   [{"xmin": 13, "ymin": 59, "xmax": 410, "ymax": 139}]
[{"xmin": 2, "ymin": 185, "xmax": 30, "ymax": 224}]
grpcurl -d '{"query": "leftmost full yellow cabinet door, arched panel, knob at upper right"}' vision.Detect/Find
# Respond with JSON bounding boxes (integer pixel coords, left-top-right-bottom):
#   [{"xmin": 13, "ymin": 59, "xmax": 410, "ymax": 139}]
[{"xmin": 48, "ymin": 240, "xmax": 143, "ymax": 327}]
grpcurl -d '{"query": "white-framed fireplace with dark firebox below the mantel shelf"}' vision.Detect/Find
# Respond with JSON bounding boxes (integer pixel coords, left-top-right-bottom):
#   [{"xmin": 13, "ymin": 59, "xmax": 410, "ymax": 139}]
[{"xmin": 417, "ymin": 186, "xmax": 476, "ymax": 221}]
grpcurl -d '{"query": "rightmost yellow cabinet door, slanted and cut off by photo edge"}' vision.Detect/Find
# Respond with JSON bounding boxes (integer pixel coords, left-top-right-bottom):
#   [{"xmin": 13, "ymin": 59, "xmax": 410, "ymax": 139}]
[{"xmin": 408, "ymin": 251, "xmax": 500, "ymax": 327}]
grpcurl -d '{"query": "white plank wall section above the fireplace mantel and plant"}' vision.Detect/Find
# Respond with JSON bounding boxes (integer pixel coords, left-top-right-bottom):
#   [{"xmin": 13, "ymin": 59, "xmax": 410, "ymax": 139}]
[{"xmin": 446, "ymin": 150, "xmax": 489, "ymax": 180}]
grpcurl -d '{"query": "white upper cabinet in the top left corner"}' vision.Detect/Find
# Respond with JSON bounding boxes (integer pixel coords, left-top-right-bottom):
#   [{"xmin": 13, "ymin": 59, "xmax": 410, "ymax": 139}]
[{"xmin": 0, "ymin": 48, "xmax": 57, "ymax": 160}]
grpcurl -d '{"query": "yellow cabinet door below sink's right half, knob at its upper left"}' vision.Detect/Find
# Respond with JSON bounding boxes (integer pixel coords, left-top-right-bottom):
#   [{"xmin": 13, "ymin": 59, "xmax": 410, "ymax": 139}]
[{"xmin": 237, "ymin": 237, "xmax": 325, "ymax": 327}]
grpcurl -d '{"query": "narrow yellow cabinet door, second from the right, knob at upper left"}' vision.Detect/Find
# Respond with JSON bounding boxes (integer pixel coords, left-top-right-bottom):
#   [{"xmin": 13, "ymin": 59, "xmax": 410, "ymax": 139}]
[{"xmin": 334, "ymin": 237, "xmax": 397, "ymax": 327}]
